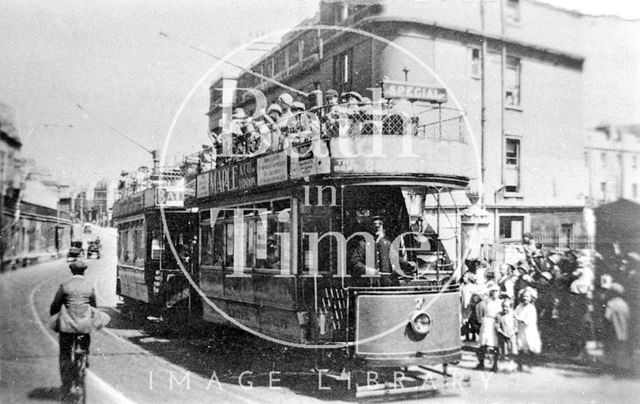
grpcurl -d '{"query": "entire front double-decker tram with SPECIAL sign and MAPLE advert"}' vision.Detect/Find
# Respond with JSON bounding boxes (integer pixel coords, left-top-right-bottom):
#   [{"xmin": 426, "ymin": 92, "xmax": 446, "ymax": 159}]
[{"xmin": 186, "ymin": 80, "xmax": 472, "ymax": 396}]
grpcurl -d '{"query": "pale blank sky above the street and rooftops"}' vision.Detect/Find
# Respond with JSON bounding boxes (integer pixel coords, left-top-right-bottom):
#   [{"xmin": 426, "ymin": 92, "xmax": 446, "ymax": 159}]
[{"xmin": 0, "ymin": 0, "xmax": 640, "ymax": 185}]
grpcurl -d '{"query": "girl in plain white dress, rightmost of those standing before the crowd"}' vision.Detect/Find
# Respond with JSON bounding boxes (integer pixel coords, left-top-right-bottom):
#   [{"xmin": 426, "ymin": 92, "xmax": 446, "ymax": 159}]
[{"xmin": 515, "ymin": 287, "xmax": 542, "ymax": 370}]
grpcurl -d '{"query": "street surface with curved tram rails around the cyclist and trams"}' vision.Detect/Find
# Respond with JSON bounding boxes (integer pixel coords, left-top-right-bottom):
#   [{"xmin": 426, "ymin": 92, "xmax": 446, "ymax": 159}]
[{"xmin": 0, "ymin": 228, "xmax": 640, "ymax": 404}]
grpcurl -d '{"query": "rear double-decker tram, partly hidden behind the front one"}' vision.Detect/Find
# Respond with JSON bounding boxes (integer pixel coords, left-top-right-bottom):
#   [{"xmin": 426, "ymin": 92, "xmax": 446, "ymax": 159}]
[{"xmin": 113, "ymin": 171, "xmax": 197, "ymax": 318}]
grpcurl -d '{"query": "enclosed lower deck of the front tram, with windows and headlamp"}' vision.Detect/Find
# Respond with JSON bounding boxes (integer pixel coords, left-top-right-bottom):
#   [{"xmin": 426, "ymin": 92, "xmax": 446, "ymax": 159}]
[{"xmin": 192, "ymin": 182, "xmax": 461, "ymax": 367}]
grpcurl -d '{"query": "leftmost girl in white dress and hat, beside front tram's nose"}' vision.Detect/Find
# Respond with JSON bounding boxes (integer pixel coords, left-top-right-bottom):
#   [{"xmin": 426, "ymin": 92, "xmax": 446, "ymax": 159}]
[{"xmin": 476, "ymin": 285, "xmax": 502, "ymax": 369}]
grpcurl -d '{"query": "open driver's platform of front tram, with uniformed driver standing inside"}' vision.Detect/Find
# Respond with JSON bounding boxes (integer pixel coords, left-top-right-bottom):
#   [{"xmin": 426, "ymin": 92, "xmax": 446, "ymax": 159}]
[{"xmin": 344, "ymin": 186, "xmax": 456, "ymax": 280}]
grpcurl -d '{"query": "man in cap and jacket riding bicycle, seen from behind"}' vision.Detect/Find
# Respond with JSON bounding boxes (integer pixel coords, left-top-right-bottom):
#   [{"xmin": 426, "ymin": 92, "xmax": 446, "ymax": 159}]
[{"xmin": 49, "ymin": 260, "xmax": 96, "ymax": 402}]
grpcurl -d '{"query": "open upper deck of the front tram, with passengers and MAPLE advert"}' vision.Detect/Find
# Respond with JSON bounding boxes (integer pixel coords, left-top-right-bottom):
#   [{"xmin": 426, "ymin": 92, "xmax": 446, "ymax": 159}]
[{"xmin": 187, "ymin": 94, "xmax": 474, "ymax": 203}]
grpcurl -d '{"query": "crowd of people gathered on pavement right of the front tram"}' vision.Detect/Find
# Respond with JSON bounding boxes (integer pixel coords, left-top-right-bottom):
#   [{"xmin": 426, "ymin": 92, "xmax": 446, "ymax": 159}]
[{"xmin": 461, "ymin": 233, "xmax": 640, "ymax": 373}]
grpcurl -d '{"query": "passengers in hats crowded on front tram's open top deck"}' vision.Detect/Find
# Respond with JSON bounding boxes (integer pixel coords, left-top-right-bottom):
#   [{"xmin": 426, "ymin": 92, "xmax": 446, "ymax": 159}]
[{"xmin": 210, "ymin": 89, "xmax": 390, "ymax": 163}]
